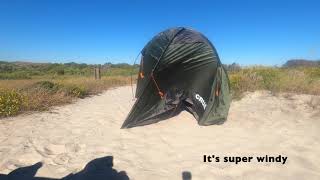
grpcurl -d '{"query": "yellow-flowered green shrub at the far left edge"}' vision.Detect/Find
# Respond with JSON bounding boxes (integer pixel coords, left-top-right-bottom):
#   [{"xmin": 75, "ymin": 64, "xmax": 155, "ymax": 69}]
[{"xmin": 0, "ymin": 90, "xmax": 23, "ymax": 117}]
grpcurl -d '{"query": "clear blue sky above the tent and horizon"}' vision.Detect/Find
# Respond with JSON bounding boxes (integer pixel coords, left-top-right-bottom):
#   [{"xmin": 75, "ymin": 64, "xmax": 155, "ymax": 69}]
[{"xmin": 0, "ymin": 0, "xmax": 320, "ymax": 65}]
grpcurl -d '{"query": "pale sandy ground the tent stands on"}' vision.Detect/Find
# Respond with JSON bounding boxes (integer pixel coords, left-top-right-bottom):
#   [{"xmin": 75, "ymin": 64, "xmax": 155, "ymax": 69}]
[{"xmin": 0, "ymin": 87, "xmax": 320, "ymax": 180}]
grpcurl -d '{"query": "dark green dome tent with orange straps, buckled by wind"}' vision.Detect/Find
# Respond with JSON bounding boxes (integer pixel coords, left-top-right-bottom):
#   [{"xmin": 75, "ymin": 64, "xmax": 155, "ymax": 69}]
[{"xmin": 122, "ymin": 27, "xmax": 231, "ymax": 128}]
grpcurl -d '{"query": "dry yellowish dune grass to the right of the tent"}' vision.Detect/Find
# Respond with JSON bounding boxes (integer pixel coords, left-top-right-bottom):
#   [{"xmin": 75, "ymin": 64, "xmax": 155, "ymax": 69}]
[{"xmin": 229, "ymin": 67, "xmax": 320, "ymax": 98}]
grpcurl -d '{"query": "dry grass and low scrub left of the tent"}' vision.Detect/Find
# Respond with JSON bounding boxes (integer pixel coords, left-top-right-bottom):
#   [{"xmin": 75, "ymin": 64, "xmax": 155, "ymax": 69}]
[{"xmin": 0, "ymin": 76, "xmax": 131, "ymax": 117}]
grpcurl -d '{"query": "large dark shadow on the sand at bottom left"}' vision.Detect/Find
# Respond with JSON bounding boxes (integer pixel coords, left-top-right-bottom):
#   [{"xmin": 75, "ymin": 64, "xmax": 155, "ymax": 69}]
[{"xmin": 0, "ymin": 156, "xmax": 129, "ymax": 180}]
